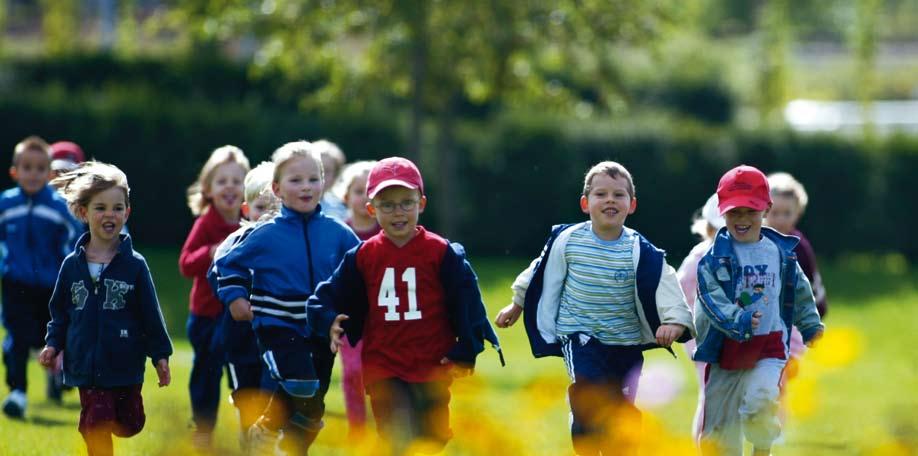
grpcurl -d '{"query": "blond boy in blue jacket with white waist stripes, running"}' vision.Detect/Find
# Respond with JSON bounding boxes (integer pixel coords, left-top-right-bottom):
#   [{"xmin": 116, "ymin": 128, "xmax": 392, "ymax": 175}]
[{"xmin": 216, "ymin": 141, "xmax": 360, "ymax": 454}]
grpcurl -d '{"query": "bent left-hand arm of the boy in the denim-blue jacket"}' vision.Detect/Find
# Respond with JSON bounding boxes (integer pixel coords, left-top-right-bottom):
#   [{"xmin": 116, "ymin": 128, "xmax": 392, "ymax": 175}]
[{"xmin": 695, "ymin": 259, "xmax": 758, "ymax": 342}]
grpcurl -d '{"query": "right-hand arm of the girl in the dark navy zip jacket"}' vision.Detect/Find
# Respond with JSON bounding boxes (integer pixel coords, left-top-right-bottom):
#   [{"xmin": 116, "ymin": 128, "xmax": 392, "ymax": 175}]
[{"xmin": 136, "ymin": 260, "xmax": 172, "ymax": 370}]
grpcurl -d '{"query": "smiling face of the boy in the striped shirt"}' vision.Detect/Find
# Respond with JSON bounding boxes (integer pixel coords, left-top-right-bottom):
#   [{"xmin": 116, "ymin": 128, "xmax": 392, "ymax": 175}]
[{"xmin": 580, "ymin": 173, "xmax": 637, "ymax": 240}]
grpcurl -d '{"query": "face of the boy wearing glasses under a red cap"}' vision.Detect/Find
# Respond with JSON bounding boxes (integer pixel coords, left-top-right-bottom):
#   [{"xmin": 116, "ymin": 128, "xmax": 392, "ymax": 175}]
[{"xmin": 367, "ymin": 185, "xmax": 427, "ymax": 247}]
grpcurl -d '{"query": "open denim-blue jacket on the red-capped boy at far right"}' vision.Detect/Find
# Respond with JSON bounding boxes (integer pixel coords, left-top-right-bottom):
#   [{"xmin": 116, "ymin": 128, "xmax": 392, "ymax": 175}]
[{"xmin": 693, "ymin": 227, "xmax": 825, "ymax": 363}]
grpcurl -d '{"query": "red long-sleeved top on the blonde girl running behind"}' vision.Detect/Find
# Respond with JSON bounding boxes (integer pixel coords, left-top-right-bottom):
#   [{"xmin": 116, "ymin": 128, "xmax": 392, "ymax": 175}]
[{"xmin": 179, "ymin": 207, "xmax": 239, "ymax": 317}]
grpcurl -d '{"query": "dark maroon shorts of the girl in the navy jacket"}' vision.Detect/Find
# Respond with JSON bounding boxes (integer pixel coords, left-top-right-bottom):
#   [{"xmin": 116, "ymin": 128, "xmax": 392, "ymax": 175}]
[{"xmin": 79, "ymin": 385, "xmax": 147, "ymax": 437}]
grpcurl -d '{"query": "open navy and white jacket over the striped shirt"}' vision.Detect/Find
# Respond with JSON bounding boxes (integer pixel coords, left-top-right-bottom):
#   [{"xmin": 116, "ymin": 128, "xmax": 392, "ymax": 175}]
[{"xmin": 513, "ymin": 223, "xmax": 695, "ymax": 358}]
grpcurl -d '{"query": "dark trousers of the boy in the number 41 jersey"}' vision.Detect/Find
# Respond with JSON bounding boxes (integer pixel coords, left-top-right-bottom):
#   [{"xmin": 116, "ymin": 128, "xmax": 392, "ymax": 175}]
[{"xmin": 366, "ymin": 378, "xmax": 453, "ymax": 449}]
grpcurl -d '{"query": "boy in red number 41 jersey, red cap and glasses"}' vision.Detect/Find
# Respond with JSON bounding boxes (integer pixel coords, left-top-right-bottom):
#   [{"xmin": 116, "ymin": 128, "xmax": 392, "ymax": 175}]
[{"xmin": 307, "ymin": 157, "xmax": 500, "ymax": 454}]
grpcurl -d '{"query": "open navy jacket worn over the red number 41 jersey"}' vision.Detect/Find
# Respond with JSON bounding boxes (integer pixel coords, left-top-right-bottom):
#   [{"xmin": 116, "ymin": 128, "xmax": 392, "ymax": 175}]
[{"xmin": 307, "ymin": 242, "xmax": 504, "ymax": 366}]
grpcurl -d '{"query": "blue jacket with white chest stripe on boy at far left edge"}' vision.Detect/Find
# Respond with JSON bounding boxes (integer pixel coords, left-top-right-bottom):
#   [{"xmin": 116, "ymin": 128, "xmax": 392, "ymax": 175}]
[{"xmin": 0, "ymin": 185, "xmax": 84, "ymax": 289}]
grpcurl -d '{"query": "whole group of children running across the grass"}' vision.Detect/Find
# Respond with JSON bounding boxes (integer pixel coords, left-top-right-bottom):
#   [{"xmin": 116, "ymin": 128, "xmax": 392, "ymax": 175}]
[{"xmin": 0, "ymin": 137, "xmax": 825, "ymax": 455}]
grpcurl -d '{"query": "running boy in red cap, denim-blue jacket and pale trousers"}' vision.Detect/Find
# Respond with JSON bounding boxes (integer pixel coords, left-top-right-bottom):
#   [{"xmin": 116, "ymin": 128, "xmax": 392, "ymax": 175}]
[{"xmin": 694, "ymin": 165, "xmax": 824, "ymax": 455}]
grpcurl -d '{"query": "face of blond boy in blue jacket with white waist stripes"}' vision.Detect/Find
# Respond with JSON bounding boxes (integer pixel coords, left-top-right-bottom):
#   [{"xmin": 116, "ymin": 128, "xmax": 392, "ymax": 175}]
[{"xmin": 271, "ymin": 157, "xmax": 322, "ymax": 214}]
